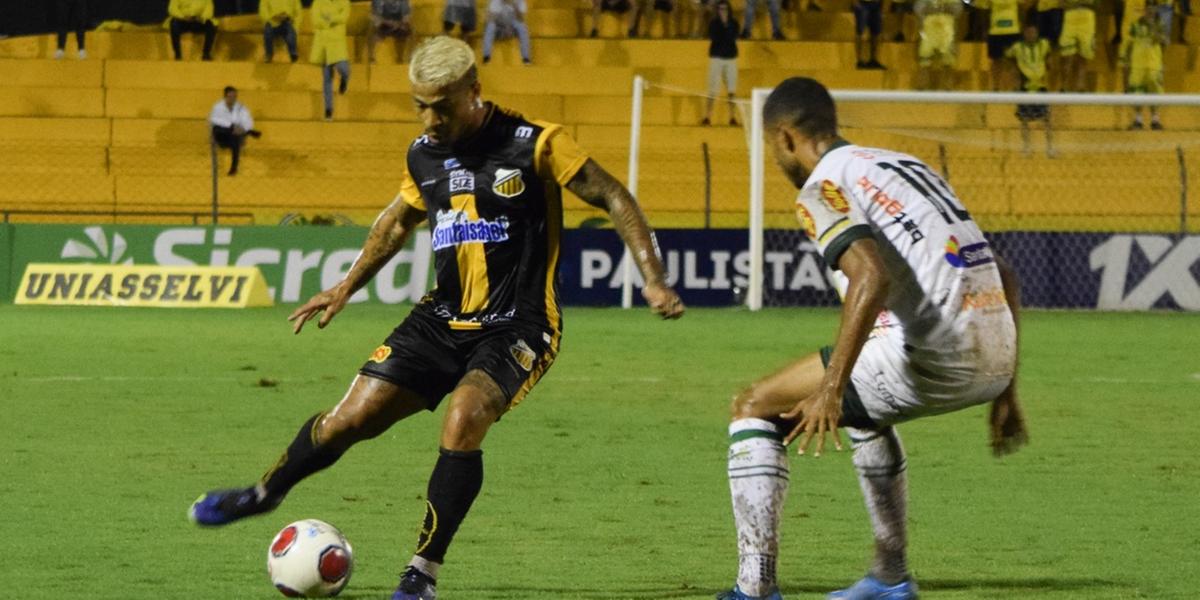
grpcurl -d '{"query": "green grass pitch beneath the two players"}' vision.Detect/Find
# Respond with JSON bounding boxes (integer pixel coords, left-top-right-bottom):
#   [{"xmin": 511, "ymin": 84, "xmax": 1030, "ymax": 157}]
[{"xmin": 0, "ymin": 306, "xmax": 1200, "ymax": 600}]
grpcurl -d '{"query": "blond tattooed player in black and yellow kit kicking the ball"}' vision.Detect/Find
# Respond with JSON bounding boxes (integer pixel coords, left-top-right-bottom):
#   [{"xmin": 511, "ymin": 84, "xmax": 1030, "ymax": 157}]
[{"xmin": 191, "ymin": 37, "xmax": 684, "ymax": 600}]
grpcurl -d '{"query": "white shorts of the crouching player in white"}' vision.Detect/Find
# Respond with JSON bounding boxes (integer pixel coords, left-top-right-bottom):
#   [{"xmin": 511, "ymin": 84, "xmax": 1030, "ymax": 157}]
[{"xmin": 822, "ymin": 313, "xmax": 1016, "ymax": 428}]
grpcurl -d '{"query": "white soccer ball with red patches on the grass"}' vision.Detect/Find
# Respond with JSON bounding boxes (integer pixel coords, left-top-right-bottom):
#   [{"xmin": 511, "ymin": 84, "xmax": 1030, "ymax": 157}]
[{"xmin": 266, "ymin": 518, "xmax": 354, "ymax": 598}]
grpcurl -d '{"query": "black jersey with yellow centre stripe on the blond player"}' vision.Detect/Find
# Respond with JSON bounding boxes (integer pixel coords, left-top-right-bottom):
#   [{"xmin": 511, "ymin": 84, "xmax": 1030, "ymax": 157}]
[{"xmin": 401, "ymin": 103, "xmax": 588, "ymax": 335}]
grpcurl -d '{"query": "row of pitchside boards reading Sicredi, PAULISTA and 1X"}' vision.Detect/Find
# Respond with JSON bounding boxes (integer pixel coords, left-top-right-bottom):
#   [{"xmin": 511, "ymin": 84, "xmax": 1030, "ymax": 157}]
[{"xmin": 0, "ymin": 224, "xmax": 1200, "ymax": 311}]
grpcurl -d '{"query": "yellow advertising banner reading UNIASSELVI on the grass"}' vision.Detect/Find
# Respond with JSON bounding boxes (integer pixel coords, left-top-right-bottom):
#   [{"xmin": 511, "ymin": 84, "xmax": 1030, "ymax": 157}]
[{"xmin": 14, "ymin": 263, "xmax": 272, "ymax": 308}]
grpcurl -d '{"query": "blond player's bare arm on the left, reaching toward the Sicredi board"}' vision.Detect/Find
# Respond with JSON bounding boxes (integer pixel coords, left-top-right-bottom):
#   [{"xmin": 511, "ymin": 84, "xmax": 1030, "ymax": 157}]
[{"xmin": 288, "ymin": 196, "xmax": 425, "ymax": 334}]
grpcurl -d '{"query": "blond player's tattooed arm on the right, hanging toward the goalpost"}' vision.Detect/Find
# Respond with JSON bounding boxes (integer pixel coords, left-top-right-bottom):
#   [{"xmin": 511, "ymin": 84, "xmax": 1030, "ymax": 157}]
[{"xmin": 566, "ymin": 158, "xmax": 684, "ymax": 319}]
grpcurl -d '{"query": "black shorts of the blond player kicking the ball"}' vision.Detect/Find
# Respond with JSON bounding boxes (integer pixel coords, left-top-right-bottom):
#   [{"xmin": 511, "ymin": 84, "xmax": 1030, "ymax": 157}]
[{"xmin": 359, "ymin": 307, "xmax": 558, "ymax": 410}]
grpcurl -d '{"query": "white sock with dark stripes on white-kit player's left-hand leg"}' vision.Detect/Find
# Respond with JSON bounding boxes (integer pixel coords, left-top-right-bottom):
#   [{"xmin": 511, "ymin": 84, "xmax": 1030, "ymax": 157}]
[{"xmin": 728, "ymin": 419, "xmax": 788, "ymax": 596}]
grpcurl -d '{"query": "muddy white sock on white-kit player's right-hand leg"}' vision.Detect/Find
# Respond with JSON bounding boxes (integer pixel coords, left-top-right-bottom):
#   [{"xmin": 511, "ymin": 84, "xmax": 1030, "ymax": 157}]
[{"xmin": 847, "ymin": 427, "xmax": 908, "ymax": 583}]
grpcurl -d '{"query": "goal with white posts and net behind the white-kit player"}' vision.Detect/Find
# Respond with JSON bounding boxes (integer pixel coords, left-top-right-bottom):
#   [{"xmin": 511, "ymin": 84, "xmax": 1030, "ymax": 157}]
[{"xmin": 614, "ymin": 82, "xmax": 1200, "ymax": 310}]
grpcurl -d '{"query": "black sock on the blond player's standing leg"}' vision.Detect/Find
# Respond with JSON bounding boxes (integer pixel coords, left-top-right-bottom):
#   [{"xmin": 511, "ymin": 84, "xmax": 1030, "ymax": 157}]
[{"xmin": 416, "ymin": 448, "xmax": 484, "ymax": 564}]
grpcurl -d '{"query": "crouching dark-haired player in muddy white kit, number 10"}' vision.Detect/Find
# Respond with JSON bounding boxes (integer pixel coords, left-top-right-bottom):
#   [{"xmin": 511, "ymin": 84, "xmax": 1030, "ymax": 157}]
[{"xmin": 718, "ymin": 78, "xmax": 1026, "ymax": 600}]
